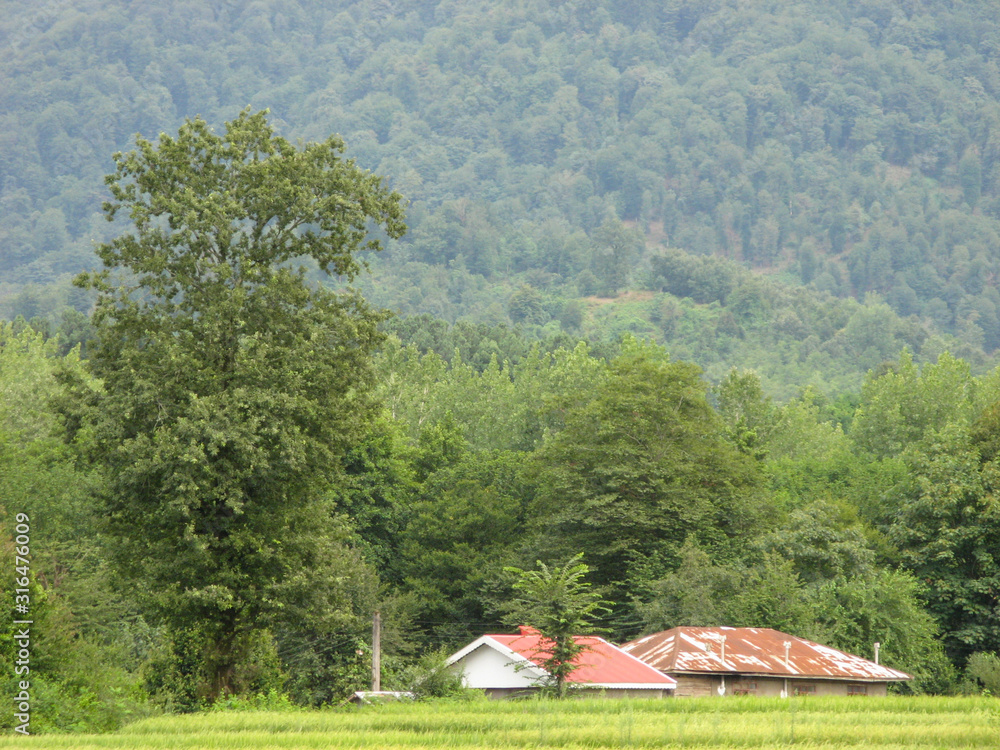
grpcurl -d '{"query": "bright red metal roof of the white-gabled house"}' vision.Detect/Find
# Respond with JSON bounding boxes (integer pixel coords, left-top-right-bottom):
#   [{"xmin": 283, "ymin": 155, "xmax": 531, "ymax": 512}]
[{"xmin": 485, "ymin": 627, "xmax": 677, "ymax": 689}]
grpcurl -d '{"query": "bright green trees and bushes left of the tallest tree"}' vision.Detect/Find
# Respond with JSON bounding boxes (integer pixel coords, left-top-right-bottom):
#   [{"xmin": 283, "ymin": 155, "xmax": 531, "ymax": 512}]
[{"xmin": 0, "ymin": 324, "xmax": 149, "ymax": 731}]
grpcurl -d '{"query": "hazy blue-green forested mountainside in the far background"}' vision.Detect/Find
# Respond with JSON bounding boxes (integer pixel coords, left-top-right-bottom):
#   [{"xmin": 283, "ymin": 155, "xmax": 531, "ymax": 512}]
[{"xmin": 0, "ymin": 0, "xmax": 1000, "ymax": 393}]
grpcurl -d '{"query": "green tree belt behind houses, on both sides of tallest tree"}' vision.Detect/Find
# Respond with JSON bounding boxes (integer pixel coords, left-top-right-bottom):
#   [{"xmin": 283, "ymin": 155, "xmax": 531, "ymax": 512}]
[{"xmin": 0, "ymin": 308, "xmax": 1000, "ymax": 728}]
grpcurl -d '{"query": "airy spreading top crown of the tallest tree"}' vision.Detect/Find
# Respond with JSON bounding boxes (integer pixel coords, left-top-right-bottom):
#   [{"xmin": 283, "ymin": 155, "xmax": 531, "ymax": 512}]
[{"xmin": 93, "ymin": 110, "xmax": 405, "ymax": 288}]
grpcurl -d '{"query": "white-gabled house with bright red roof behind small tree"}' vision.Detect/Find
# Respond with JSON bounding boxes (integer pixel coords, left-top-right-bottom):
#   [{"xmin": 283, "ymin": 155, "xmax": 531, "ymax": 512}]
[{"xmin": 447, "ymin": 627, "xmax": 676, "ymax": 698}]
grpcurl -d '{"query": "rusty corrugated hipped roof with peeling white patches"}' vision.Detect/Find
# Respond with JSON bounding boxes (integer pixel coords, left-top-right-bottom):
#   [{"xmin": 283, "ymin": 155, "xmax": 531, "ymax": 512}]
[{"xmin": 621, "ymin": 628, "xmax": 912, "ymax": 682}]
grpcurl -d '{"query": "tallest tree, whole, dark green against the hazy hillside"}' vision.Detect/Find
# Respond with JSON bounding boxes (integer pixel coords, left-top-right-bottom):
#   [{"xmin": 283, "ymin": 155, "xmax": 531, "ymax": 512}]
[{"xmin": 78, "ymin": 111, "xmax": 405, "ymax": 699}]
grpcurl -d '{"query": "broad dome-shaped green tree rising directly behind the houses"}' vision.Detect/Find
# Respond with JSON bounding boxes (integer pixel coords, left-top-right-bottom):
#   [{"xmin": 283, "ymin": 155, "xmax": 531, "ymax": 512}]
[{"xmin": 535, "ymin": 340, "xmax": 759, "ymax": 602}]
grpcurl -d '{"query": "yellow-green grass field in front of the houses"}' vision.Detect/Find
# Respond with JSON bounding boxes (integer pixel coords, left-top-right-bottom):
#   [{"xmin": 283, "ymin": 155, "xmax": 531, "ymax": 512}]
[{"xmin": 0, "ymin": 697, "xmax": 1000, "ymax": 750}]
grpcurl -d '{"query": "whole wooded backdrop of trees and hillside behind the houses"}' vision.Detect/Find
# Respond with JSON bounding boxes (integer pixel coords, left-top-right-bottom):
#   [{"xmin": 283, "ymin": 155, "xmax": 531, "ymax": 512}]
[{"xmin": 0, "ymin": 0, "xmax": 1000, "ymax": 729}]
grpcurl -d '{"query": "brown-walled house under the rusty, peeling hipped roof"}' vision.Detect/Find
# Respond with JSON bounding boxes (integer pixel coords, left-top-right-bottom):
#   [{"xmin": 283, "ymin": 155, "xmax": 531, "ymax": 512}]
[{"xmin": 622, "ymin": 628, "xmax": 912, "ymax": 697}]
